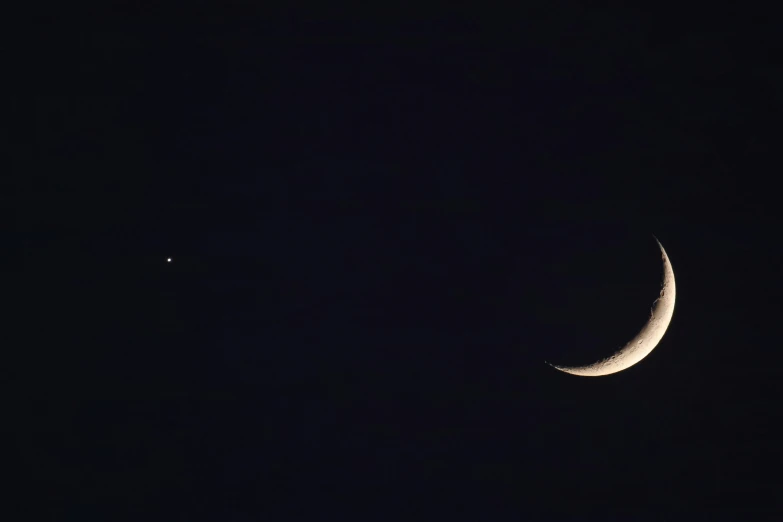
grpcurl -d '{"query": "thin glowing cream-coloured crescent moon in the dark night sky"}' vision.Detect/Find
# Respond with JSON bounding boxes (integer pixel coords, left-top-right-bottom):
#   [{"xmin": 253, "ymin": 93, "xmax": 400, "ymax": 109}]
[{"xmin": 547, "ymin": 236, "xmax": 677, "ymax": 377}]
